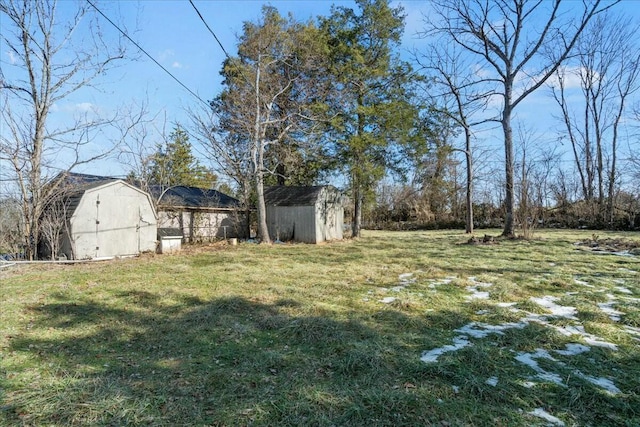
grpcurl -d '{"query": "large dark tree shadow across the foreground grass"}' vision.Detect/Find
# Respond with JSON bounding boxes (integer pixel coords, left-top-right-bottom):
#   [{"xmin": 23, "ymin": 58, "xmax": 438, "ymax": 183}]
[{"xmin": 0, "ymin": 291, "xmax": 638, "ymax": 426}]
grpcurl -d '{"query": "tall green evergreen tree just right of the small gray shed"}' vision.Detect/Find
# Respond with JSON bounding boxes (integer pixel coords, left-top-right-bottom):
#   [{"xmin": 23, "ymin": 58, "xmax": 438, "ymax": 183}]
[{"xmin": 321, "ymin": 0, "xmax": 420, "ymax": 237}]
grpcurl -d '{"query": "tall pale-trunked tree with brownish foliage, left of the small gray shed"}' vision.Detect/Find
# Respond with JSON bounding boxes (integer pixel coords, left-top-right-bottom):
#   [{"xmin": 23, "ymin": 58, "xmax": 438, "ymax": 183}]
[{"xmin": 212, "ymin": 6, "xmax": 324, "ymax": 243}]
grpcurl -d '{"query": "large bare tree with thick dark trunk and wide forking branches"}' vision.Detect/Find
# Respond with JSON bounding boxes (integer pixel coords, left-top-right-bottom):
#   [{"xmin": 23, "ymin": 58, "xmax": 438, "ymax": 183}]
[{"xmin": 427, "ymin": 0, "xmax": 615, "ymax": 236}]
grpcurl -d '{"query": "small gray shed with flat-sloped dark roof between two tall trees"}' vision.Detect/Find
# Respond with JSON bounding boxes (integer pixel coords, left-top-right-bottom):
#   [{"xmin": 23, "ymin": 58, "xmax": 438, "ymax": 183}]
[{"xmin": 264, "ymin": 186, "xmax": 344, "ymax": 243}]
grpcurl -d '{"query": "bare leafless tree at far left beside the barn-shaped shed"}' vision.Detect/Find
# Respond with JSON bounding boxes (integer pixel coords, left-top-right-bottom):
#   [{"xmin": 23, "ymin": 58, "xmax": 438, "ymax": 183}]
[{"xmin": 0, "ymin": 0, "xmax": 124, "ymax": 259}]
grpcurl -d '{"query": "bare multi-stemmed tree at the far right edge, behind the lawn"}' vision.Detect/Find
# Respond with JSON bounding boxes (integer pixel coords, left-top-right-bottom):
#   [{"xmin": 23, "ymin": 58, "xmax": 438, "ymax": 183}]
[{"xmin": 552, "ymin": 14, "xmax": 640, "ymax": 223}]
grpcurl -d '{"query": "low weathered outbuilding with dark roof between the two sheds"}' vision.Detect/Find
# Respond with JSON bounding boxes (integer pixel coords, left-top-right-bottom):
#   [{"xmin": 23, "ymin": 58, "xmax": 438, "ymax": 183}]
[{"xmin": 150, "ymin": 185, "xmax": 247, "ymax": 243}]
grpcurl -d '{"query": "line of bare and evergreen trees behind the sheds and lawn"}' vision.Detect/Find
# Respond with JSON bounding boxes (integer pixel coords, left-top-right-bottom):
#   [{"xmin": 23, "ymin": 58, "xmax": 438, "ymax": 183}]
[{"xmin": 0, "ymin": 0, "xmax": 640, "ymax": 253}]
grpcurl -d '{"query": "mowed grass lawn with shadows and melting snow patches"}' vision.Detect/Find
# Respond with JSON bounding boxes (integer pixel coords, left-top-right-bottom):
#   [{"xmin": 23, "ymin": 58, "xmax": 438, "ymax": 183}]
[{"xmin": 0, "ymin": 230, "xmax": 640, "ymax": 426}]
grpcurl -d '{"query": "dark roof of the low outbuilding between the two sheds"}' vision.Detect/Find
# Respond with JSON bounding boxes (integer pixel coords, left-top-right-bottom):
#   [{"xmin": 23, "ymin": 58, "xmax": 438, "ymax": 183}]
[{"xmin": 149, "ymin": 185, "xmax": 240, "ymax": 209}]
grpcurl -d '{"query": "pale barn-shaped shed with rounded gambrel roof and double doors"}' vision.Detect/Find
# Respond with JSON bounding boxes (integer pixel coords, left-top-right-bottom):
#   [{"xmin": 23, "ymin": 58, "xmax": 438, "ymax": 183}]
[{"xmin": 44, "ymin": 174, "xmax": 157, "ymax": 259}]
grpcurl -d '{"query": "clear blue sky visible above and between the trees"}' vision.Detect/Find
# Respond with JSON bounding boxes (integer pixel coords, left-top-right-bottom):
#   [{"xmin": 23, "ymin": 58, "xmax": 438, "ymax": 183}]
[{"xmin": 0, "ymin": 0, "xmax": 640, "ymax": 186}]
